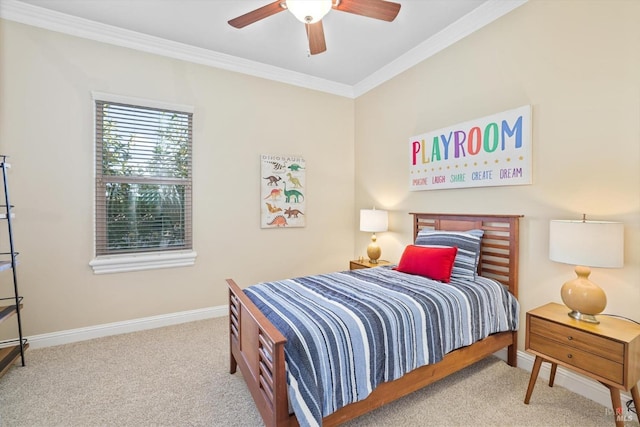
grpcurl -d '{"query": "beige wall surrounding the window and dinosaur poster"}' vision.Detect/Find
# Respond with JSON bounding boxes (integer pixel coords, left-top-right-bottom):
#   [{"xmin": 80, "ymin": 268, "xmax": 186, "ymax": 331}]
[{"xmin": 0, "ymin": 21, "xmax": 354, "ymax": 335}]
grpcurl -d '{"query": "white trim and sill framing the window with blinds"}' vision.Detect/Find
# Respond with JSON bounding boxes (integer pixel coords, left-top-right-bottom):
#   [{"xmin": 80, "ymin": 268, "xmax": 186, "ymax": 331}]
[{"xmin": 89, "ymin": 91, "xmax": 198, "ymax": 274}]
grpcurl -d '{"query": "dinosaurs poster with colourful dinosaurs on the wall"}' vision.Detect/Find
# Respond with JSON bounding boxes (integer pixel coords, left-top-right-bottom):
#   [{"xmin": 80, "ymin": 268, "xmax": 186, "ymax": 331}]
[{"xmin": 260, "ymin": 154, "xmax": 307, "ymax": 228}]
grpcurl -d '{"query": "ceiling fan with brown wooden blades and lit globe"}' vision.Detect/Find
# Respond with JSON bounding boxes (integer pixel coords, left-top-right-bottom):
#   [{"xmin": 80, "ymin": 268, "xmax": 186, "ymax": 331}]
[{"xmin": 229, "ymin": 0, "xmax": 400, "ymax": 55}]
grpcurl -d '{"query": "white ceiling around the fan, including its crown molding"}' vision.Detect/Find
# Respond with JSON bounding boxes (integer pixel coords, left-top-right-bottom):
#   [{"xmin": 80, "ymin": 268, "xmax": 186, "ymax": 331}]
[{"xmin": 0, "ymin": 0, "xmax": 526, "ymax": 96}]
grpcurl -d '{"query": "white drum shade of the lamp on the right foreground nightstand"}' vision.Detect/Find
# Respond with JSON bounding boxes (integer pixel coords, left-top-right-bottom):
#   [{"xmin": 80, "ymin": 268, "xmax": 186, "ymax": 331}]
[{"xmin": 549, "ymin": 220, "xmax": 624, "ymax": 268}]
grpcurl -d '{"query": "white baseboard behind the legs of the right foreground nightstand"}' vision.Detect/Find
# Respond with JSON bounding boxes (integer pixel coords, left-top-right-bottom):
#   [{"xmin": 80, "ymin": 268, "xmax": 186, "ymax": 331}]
[{"xmin": 495, "ymin": 349, "xmax": 638, "ymax": 422}]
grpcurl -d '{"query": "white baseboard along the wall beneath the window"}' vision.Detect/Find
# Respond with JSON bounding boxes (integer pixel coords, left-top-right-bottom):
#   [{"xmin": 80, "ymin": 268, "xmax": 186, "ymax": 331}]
[{"xmin": 27, "ymin": 306, "xmax": 229, "ymax": 349}]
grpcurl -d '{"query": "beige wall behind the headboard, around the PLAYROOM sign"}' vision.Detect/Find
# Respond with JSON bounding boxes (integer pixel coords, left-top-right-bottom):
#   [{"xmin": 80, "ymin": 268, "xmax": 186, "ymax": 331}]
[{"xmin": 354, "ymin": 0, "xmax": 640, "ymax": 352}]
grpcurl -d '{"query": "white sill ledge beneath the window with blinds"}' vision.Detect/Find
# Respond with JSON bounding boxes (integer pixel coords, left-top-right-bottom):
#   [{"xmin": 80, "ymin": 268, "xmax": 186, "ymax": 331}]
[{"xmin": 89, "ymin": 250, "xmax": 198, "ymax": 274}]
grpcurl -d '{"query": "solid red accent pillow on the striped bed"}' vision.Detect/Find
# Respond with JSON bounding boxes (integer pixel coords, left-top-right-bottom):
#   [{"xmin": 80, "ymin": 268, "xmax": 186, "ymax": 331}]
[{"xmin": 395, "ymin": 245, "xmax": 458, "ymax": 283}]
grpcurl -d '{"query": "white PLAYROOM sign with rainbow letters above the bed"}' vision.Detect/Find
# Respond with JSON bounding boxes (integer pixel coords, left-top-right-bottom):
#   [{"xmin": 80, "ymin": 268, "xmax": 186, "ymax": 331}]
[{"xmin": 409, "ymin": 105, "xmax": 532, "ymax": 191}]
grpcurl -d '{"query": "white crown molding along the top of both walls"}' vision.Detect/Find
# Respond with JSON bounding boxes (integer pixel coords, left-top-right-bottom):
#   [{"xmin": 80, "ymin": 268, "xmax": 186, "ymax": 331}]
[{"xmin": 0, "ymin": 0, "xmax": 528, "ymax": 99}]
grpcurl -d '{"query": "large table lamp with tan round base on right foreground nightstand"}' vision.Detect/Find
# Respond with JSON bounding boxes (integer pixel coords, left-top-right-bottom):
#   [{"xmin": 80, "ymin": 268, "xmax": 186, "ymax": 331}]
[{"xmin": 549, "ymin": 216, "xmax": 624, "ymax": 323}]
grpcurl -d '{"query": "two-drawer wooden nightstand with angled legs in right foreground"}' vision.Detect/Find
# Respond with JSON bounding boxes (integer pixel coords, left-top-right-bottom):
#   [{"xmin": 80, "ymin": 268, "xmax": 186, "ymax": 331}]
[{"xmin": 524, "ymin": 303, "xmax": 640, "ymax": 427}]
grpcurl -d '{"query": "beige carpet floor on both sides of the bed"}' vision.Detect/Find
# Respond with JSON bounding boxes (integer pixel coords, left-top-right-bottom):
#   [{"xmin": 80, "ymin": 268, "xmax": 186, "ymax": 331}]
[{"xmin": 0, "ymin": 318, "xmax": 638, "ymax": 427}]
